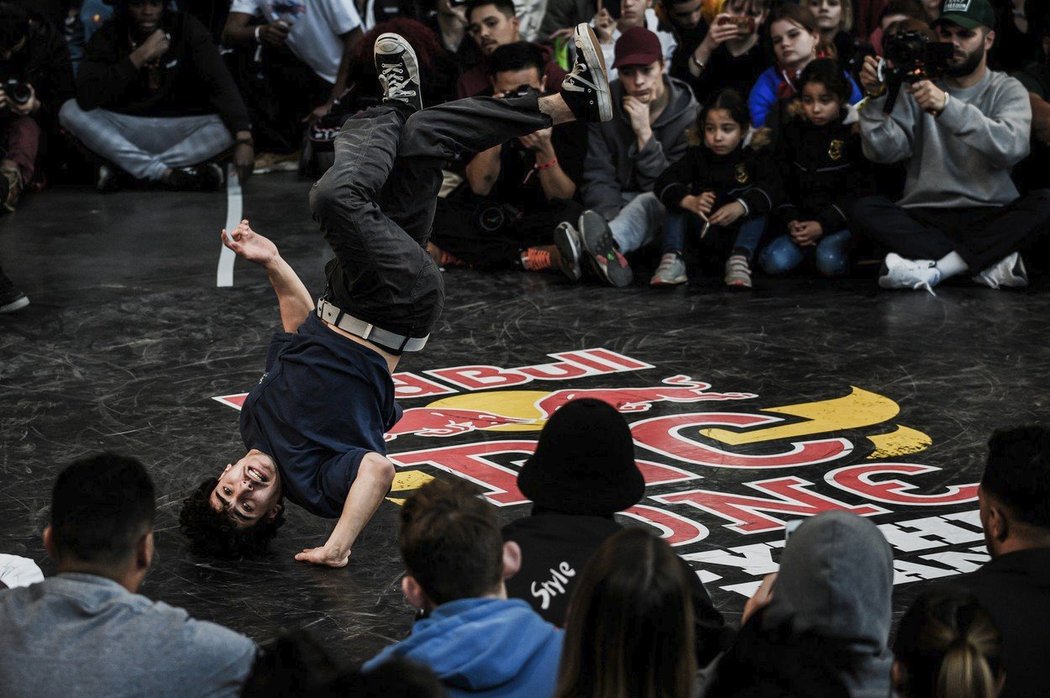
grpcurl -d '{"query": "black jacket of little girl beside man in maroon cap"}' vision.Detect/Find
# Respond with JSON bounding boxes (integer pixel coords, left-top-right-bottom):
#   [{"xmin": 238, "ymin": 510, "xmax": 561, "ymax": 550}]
[{"xmin": 653, "ymin": 138, "xmax": 780, "ymax": 218}]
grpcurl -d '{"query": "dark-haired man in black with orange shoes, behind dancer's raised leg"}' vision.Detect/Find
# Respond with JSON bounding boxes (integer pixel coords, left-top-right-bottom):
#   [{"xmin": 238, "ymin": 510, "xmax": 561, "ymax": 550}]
[{"xmin": 427, "ymin": 41, "xmax": 587, "ymax": 278}]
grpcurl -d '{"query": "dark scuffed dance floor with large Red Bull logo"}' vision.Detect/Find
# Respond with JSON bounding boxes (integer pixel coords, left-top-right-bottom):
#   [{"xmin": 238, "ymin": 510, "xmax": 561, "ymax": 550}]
[{"xmin": 0, "ymin": 174, "xmax": 1050, "ymax": 660}]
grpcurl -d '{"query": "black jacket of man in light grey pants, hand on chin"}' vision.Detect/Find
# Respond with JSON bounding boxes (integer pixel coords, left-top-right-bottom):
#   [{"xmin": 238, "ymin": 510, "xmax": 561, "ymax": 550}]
[{"xmin": 77, "ymin": 12, "xmax": 251, "ymax": 132}]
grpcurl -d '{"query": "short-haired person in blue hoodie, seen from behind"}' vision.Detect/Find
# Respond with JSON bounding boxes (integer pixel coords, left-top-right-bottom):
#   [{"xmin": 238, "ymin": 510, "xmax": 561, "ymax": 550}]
[{"xmin": 363, "ymin": 480, "xmax": 562, "ymax": 698}]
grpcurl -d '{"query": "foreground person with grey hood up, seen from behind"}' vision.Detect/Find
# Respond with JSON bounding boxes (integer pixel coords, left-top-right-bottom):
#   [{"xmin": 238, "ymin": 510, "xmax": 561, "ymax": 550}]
[{"xmin": 705, "ymin": 511, "xmax": 894, "ymax": 698}]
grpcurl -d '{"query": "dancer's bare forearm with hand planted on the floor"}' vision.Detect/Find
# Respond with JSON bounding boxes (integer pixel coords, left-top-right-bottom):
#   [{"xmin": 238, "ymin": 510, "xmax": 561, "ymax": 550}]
[{"xmin": 295, "ymin": 452, "xmax": 394, "ymax": 567}]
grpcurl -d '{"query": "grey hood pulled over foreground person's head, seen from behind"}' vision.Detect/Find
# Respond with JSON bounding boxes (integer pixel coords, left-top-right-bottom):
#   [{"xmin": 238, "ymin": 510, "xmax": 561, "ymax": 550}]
[{"xmin": 764, "ymin": 511, "xmax": 894, "ymax": 698}]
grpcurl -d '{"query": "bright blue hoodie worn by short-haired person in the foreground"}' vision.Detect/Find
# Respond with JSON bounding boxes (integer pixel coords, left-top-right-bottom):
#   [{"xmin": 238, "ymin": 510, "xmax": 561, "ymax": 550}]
[{"xmin": 363, "ymin": 598, "xmax": 563, "ymax": 698}]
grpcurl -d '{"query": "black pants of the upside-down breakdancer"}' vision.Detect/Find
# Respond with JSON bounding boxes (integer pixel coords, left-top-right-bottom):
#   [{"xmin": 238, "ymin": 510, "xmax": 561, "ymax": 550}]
[{"xmin": 310, "ymin": 93, "xmax": 551, "ymax": 337}]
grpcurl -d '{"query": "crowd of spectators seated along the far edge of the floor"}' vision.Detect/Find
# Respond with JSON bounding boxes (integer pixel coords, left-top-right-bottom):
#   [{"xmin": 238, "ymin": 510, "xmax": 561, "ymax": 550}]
[{"xmin": 0, "ymin": 0, "xmax": 1050, "ymax": 312}]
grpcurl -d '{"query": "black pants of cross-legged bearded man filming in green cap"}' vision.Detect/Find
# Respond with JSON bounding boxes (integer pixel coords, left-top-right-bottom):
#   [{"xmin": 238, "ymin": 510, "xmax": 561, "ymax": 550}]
[{"xmin": 849, "ymin": 190, "xmax": 1050, "ymax": 272}]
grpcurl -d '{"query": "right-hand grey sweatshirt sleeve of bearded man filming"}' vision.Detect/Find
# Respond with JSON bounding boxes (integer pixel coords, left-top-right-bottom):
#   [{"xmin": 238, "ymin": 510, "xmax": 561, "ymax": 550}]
[{"xmin": 937, "ymin": 78, "xmax": 1032, "ymax": 169}]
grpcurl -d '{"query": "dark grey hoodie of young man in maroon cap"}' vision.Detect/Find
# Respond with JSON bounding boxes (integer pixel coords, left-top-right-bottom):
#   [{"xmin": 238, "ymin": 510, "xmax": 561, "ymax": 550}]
[{"xmin": 583, "ymin": 76, "xmax": 699, "ymax": 219}]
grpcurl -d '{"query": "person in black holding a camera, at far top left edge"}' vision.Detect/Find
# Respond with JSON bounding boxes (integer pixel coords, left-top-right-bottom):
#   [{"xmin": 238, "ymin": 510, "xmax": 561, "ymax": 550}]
[{"xmin": 0, "ymin": 2, "xmax": 74, "ymax": 212}]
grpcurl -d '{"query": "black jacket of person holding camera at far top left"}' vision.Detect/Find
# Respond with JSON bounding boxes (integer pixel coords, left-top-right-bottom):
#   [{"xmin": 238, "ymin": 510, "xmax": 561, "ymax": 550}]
[{"xmin": 0, "ymin": 14, "xmax": 74, "ymax": 124}]
